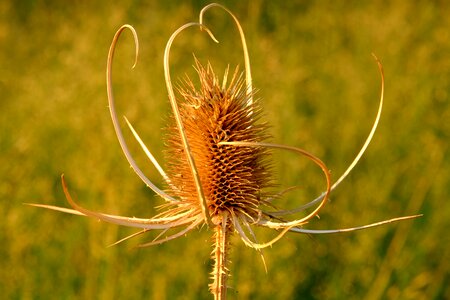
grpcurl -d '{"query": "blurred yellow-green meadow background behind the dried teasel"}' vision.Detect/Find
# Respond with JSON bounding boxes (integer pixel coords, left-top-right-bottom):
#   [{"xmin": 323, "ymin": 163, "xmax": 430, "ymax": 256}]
[{"xmin": 0, "ymin": 0, "xmax": 450, "ymax": 299}]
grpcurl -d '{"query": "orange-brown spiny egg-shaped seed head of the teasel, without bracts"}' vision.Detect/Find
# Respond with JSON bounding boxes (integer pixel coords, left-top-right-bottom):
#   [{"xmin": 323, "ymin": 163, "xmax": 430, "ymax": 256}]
[{"xmin": 166, "ymin": 61, "xmax": 270, "ymax": 220}]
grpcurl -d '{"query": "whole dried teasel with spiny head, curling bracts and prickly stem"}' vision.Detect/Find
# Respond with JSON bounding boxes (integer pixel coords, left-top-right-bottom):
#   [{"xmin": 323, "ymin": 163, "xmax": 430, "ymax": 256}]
[{"xmin": 31, "ymin": 3, "xmax": 418, "ymax": 299}]
